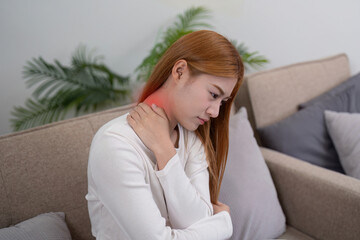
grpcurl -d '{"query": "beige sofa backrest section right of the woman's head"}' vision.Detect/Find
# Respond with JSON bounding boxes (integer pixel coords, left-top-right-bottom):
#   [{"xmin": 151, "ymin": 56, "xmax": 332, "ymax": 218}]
[{"xmin": 245, "ymin": 54, "xmax": 350, "ymax": 127}]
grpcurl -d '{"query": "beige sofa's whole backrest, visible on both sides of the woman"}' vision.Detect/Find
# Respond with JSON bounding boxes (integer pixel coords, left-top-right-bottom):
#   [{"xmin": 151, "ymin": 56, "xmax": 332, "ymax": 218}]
[{"xmin": 0, "ymin": 54, "xmax": 350, "ymax": 240}]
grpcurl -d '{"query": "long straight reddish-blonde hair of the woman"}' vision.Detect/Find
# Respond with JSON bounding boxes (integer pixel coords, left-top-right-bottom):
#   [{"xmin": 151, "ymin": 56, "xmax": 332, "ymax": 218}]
[{"xmin": 138, "ymin": 30, "xmax": 244, "ymax": 203}]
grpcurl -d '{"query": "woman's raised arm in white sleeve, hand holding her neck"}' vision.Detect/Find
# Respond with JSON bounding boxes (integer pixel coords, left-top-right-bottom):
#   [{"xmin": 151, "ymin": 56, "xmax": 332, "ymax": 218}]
[{"xmin": 127, "ymin": 103, "xmax": 222, "ymax": 229}]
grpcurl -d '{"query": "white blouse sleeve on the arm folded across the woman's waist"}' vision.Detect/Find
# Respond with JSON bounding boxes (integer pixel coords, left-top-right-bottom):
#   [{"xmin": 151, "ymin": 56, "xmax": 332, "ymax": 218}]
[{"xmin": 89, "ymin": 131, "xmax": 232, "ymax": 240}]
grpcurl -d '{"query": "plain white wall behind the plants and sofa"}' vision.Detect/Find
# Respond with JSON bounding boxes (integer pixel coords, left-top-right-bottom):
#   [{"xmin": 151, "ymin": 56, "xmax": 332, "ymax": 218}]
[{"xmin": 0, "ymin": 0, "xmax": 360, "ymax": 135}]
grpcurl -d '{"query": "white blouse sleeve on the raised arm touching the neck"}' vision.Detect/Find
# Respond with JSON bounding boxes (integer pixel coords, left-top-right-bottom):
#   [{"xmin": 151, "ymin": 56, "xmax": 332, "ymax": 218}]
[{"xmin": 156, "ymin": 134, "xmax": 213, "ymax": 229}]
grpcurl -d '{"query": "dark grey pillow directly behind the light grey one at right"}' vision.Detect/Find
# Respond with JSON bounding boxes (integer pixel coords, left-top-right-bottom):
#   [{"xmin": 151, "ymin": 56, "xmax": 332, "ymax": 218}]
[{"xmin": 258, "ymin": 88, "xmax": 356, "ymax": 173}]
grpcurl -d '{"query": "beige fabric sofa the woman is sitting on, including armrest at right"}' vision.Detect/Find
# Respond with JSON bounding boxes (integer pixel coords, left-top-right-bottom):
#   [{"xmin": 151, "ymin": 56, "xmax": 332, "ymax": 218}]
[{"xmin": 0, "ymin": 54, "xmax": 360, "ymax": 240}]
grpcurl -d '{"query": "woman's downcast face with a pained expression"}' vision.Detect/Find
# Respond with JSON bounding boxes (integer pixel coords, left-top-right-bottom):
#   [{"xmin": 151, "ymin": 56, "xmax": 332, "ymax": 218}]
[{"xmin": 172, "ymin": 74, "xmax": 237, "ymax": 131}]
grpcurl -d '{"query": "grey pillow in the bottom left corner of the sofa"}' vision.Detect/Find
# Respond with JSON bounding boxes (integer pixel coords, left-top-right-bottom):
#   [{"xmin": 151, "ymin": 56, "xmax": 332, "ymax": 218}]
[{"xmin": 0, "ymin": 212, "xmax": 71, "ymax": 240}]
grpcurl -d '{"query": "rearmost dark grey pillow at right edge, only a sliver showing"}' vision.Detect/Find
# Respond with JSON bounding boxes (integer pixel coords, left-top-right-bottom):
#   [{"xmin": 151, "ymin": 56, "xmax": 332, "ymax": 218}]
[{"xmin": 299, "ymin": 73, "xmax": 360, "ymax": 109}]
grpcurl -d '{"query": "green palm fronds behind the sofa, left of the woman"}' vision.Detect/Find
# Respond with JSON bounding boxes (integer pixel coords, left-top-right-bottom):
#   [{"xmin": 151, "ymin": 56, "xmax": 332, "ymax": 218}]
[{"xmin": 11, "ymin": 46, "xmax": 130, "ymax": 131}]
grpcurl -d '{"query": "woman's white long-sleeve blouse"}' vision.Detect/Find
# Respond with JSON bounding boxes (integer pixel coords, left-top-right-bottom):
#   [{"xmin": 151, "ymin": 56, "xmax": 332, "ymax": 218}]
[{"xmin": 86, "ymin": 114, "xmax": 232, "ymax": 240}]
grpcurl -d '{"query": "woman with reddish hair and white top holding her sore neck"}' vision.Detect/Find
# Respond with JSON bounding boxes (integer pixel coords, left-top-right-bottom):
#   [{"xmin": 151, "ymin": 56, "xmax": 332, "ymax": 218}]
[{"xmin": 86, "ymin": 30, "xmax": 244, "ymax": 240}]
